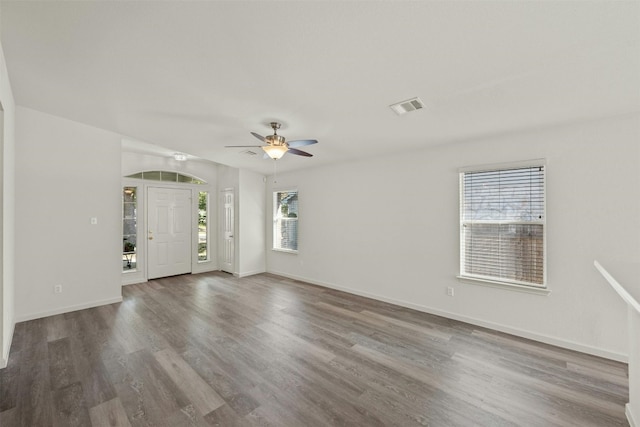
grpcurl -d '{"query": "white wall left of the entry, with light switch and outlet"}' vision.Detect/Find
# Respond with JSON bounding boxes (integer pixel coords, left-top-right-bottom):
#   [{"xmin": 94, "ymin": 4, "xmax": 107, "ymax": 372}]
[{"xmin": 16, "ymin": 107, "xmax": 122, "ymax": 320}]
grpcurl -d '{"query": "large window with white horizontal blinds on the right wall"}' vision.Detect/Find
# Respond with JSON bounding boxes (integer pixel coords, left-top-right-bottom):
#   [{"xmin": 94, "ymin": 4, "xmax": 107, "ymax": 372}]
[{"xmin": 460, "ymin": 163, "xmax": 546, "ymax": 287}]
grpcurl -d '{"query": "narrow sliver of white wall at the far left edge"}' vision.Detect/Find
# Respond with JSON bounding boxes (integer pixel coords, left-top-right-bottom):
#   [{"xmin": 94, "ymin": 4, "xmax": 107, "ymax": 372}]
[{"xmin": 0, "ymin": 39, "xmax": 16, "ymax": 368}]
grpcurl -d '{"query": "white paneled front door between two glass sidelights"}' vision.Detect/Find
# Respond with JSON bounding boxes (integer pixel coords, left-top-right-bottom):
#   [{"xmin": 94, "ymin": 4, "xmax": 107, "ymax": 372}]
[{"xmin": 147, "ymin": 187, "xmax": 192, "ymax": 279}]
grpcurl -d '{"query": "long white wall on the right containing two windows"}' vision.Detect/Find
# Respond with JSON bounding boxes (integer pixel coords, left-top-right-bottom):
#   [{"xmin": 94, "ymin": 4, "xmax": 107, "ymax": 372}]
[{"xmin": 267, "ymin": 116, "xmax": 640, "ymax": 360}]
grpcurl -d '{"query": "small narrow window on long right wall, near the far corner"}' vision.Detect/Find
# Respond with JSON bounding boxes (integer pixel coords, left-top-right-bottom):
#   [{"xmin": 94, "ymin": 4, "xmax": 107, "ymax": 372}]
[{"xmin": 273, "ymin": 191, "xmax": 298, "ymax": 252}]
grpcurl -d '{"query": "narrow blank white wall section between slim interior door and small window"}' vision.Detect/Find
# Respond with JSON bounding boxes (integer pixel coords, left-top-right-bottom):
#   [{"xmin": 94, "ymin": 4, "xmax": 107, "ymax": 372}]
[{"xmin": 238, "ymin": 169, "xmax": 266, "ymax": 277}]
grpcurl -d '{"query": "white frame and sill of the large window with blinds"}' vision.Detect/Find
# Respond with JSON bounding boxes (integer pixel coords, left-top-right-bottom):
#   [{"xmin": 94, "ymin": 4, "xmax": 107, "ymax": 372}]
[{"xmin": 456, "ymin": 159, "xmax": 550, "ymax": 295}]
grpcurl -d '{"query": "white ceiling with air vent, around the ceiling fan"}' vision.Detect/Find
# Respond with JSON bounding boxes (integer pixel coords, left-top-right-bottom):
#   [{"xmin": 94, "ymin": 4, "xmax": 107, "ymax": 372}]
[{"xmin": 0, "ymin": 0, "xmax": 640, "ymax": 174}]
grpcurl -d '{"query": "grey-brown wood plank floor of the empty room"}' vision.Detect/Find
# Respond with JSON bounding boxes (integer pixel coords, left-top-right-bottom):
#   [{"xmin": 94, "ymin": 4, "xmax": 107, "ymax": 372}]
[{"xmin": 0, "ymin": 273, "xmax": 628, "ymax": 427}]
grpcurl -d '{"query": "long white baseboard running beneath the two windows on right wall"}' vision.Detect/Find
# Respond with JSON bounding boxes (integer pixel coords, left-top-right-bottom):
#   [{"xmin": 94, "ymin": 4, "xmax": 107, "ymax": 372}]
[{"xmin": 268, "ymin": 270, "xmax": 628, "ymax": 363}]
